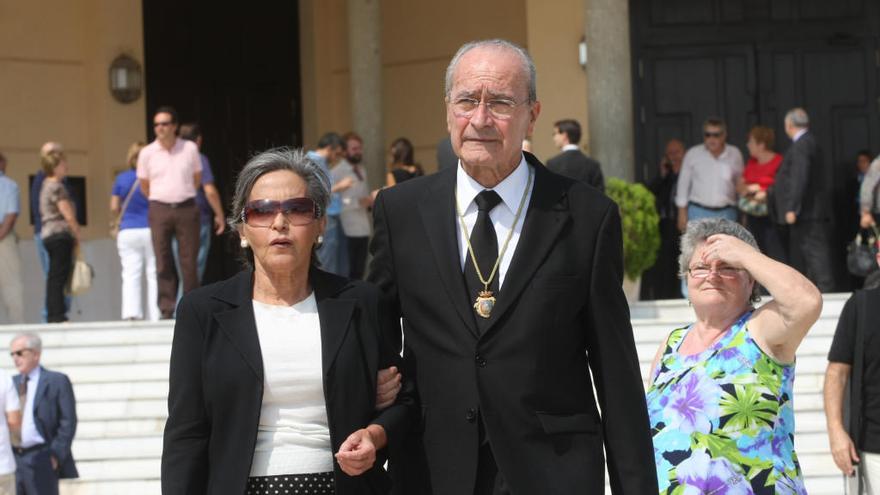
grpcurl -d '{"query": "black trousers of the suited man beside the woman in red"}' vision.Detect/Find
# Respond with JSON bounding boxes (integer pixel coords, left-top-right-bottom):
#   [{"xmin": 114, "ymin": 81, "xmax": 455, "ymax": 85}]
[{"xmin": 788, "ymin": 219, "xmax": 834, "ymax": 292}]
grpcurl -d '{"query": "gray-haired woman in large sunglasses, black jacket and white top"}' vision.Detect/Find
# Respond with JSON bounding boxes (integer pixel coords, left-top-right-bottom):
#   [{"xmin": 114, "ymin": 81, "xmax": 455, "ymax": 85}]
[{"xmin": 162, "ymin": 149, "xmax": 414, "ymax": 495}]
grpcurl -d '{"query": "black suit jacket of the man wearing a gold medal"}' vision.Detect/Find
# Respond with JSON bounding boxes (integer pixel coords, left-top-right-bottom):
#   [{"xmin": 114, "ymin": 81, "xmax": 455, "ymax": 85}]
[{"xmin": 370, "ymin": 154, "xmax": 657, "ymax": 495}]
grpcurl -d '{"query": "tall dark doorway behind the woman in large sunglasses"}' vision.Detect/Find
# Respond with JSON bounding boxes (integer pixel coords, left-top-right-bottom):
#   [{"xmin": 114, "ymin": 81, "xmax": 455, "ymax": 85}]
[{"xmin": 143, "ymin": 0, "xmax": 302, "ymax": 282}]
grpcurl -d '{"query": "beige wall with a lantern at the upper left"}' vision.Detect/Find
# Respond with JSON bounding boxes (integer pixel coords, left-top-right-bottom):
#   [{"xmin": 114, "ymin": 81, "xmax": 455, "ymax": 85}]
[{"xmin": 0, "ymin": 0, "xmax": 146, "ymax": 239}]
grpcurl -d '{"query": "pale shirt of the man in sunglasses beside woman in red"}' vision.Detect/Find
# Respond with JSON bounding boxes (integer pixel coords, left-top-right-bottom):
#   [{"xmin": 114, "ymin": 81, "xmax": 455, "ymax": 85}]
[{"xmin": 675, "ymin": 144, "xmax": 743, "ymax": 208}]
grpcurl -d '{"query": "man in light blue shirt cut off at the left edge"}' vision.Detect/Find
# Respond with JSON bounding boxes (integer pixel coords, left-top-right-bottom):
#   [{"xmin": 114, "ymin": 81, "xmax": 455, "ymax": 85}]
[{"xmin": 0, "ymin": 153, "xmax": 24, "ymax": 323}]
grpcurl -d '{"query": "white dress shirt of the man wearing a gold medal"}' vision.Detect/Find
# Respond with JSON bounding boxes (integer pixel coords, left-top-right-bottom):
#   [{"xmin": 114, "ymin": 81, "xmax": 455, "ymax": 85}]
[{"xmin": 455, "ymin": 157, "xmax": 535, "ymax": 289}]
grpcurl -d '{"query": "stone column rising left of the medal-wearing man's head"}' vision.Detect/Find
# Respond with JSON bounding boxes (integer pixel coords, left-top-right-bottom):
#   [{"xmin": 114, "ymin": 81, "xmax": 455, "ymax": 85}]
[{"xmin": 348, "ymin": 0, "xmax": 385, "ymax": 188}]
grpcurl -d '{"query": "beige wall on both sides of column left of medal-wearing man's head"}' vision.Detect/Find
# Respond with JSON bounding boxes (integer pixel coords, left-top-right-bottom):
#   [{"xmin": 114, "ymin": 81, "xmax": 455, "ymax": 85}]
[{"xmin": 300, "ymin": 0, "xmax": 528, "ymax": 182}]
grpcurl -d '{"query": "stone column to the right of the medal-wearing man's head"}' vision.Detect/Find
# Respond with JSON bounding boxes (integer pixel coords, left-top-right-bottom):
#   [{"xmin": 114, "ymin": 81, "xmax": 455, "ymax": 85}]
[{"xmin": 584, "ymin": 0, "xmax": 635, "ymax": 180}]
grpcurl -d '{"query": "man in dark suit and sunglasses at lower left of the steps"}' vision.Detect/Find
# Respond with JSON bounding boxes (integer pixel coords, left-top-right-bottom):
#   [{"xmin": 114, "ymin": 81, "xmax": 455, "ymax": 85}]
[{"xmin": 10, "ymin": 333, "xmax": 79, "ymax": 495}]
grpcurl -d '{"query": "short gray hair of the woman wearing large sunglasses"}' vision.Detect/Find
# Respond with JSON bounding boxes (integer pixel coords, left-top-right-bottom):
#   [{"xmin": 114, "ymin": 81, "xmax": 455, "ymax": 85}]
[{"xmin": 226, "ymin": 147, "xmax": 330, "ymax": 230}]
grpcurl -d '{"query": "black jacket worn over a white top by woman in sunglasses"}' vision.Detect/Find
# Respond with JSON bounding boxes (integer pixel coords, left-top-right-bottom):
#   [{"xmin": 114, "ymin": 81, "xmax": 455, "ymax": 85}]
[{"xmin": 162, "ymin": 270, "xmax": 413, "ymax": 495}]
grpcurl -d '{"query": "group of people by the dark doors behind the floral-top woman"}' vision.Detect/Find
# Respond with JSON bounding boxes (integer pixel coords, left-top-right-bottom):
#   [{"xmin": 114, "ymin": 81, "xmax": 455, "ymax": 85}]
[{"xmin": 642, "ymin": 108, "xmax": 880, "ymax": 299}]
